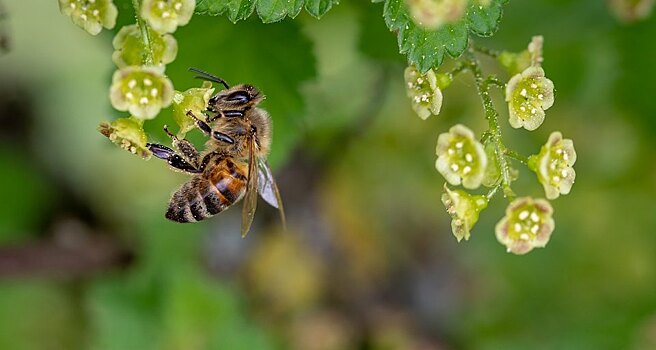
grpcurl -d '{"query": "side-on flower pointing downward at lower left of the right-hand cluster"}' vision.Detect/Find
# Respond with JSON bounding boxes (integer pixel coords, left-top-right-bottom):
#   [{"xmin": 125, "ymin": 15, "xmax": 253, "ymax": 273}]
[{"xmin": 442, "ymin": 184, "xmax": 488, "ymax": 242}]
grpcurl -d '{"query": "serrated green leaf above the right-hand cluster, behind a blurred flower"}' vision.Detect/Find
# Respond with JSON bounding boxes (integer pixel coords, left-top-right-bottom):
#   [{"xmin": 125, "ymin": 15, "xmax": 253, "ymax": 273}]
[{"xmin": 383, "ymin": 0, "xmax": 507, "ymax": 73}]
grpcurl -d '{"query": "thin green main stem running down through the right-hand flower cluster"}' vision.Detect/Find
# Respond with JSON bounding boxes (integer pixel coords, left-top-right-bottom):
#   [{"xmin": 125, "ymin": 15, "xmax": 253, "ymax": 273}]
[{"xmin": 465, "ymin": 48, "xmax": 515, "ymax": 200}]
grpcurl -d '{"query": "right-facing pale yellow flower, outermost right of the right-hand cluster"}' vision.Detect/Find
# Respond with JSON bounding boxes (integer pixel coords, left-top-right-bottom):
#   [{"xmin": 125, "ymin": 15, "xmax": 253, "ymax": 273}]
[{"xmin": 528, "ymin": 131, "xmax": 576, "ymax": 199}]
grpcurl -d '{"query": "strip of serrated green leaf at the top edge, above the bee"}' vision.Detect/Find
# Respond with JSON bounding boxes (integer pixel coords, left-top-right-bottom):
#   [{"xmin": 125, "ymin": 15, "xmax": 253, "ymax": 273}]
[{"xmin": 196, "ymin": 0, "xmax": 339, "ymax": 23}]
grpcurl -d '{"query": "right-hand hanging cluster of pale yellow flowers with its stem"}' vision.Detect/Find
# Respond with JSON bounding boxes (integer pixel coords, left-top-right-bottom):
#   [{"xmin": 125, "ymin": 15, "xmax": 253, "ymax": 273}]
[{"xmin": 405, "ymin": 34, "xmax": 576, "ymax": 254}]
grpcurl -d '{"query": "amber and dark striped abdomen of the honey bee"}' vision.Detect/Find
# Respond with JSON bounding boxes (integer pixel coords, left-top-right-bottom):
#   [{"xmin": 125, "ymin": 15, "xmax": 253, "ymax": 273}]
[{"xmin": 166, "ymin": 158, "xmax": 248, "ymax": 222}]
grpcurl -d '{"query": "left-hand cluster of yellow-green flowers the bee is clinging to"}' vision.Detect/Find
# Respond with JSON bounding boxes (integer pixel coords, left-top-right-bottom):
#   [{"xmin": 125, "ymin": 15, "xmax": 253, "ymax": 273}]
[{"xmin": 88, "ymin": 0, "xmax": 197, "ymax": 157}]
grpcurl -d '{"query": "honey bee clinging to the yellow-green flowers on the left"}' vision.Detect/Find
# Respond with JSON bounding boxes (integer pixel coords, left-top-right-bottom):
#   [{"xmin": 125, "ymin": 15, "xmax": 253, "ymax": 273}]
[{"xmin": 147, "ymin": 68, "xmax": 285, "ymax": 236}]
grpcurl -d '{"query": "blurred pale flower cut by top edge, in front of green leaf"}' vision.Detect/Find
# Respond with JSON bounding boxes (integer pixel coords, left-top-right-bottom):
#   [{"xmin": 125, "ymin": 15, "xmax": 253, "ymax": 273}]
[{"xmin": 406, "ymin": 0, "xmax": 468, "ymax": 30}]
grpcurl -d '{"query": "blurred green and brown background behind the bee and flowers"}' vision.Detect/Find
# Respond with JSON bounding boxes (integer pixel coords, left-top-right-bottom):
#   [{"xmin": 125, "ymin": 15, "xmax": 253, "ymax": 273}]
[{"xmin": 0, "ymin": 0, "xmax": 656, "ymax": 350}]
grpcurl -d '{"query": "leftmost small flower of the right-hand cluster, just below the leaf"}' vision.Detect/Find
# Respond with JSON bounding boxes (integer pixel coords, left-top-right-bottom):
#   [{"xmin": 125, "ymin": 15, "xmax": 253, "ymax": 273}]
[{"xmin": 404, "ymin": 66, "xmax": 442, "ymax": 120}]
